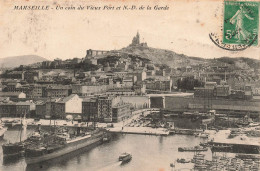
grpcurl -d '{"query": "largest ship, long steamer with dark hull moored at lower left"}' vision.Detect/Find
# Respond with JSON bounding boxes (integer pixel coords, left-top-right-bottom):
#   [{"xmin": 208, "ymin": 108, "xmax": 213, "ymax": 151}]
[{"xmin": 25, "ymin": 128, "xmax": 104, "ymax": 165}]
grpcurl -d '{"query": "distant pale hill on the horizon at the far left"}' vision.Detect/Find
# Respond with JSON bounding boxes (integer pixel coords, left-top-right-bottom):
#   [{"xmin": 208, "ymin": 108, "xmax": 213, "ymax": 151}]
[{"xmin": 0, "ymin": 55, "xmax": 47, "ymax": 68}]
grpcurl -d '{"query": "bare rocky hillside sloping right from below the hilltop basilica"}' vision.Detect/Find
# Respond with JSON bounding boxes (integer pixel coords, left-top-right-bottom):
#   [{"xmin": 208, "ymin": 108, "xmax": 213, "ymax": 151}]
[{"xmin": 119, "ymin": 46, "xmax": 260, "ymax": 69}]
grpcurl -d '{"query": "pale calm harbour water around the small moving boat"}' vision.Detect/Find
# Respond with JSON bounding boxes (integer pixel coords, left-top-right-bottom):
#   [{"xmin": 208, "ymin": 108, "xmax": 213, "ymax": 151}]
[{"xmin": 0, "ymin": 128, "xmax": 211, "ymax": 171}]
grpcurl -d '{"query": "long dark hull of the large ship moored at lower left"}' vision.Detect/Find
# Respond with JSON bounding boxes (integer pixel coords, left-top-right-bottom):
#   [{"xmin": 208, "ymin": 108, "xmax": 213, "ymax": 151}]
[{"xmin": 25, "ymin": 134, "xmax": 103, "ymax": 165}]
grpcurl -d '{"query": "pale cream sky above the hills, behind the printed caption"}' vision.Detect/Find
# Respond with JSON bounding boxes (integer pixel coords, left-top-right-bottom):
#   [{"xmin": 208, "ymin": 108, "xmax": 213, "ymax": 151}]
[{"xmin": 0, "ymin": 0, "xmax": 260, "ymax": 60}]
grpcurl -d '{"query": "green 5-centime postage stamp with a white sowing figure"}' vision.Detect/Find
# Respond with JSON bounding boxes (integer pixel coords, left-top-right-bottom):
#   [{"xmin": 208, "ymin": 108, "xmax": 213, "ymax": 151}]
[{"xmin": 223, "ymin": 1, "xmax": 259, "ymax": 46}]
